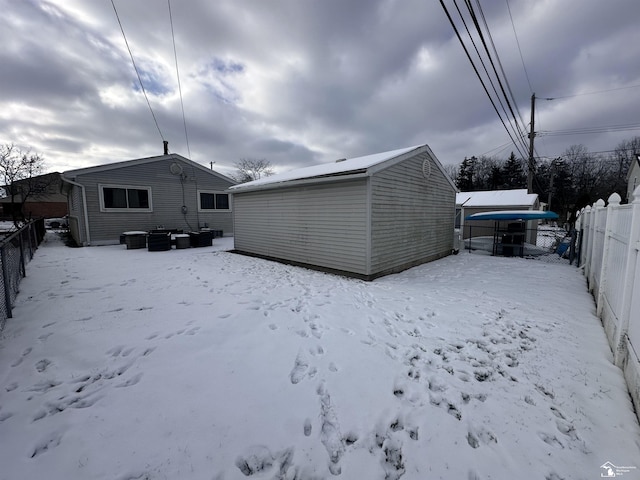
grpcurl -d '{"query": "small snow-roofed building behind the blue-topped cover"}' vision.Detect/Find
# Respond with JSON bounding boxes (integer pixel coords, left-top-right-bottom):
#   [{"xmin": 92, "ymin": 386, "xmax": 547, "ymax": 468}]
[{"xmin": 456, "ymin": 188, "xmax": 540, "ymax": 245}]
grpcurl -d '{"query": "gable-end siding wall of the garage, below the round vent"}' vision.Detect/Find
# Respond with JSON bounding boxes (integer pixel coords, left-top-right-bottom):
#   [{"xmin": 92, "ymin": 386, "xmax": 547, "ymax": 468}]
[{"xmin": 368, "ymin": 152, "xmax": 455, "ymax": 275}]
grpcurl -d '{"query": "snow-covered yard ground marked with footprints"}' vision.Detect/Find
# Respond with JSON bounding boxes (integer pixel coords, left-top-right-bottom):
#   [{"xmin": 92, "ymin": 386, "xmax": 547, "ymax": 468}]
[{"xmin": 0, "ymin": 233, "xmax": 640, "ymax": 480}]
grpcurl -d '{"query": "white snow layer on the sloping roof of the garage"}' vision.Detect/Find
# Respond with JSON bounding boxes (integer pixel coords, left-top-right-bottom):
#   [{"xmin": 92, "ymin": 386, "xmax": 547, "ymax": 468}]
[{"xmin": 229, "ymin": 145, "xmax": 422, "ymax": 190}]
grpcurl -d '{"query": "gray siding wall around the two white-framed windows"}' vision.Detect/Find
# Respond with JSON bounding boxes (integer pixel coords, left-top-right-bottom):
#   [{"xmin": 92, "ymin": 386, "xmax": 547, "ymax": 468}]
[{"xmin": 65, "ymin": 157, "xmax": 233, "ymax": 245}]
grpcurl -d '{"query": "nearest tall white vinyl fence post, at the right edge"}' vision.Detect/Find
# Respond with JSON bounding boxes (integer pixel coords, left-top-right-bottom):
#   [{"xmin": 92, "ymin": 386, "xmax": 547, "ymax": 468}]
[{"xmin": 613, "ymin": 186, "xmax": 640, "ymax": 367}]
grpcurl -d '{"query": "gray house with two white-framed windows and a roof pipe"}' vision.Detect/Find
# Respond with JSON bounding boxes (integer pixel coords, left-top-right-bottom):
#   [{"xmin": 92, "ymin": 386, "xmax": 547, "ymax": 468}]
[{"xmin": 62, "ymin": 153, "xmax": 235, "ymax": 246}]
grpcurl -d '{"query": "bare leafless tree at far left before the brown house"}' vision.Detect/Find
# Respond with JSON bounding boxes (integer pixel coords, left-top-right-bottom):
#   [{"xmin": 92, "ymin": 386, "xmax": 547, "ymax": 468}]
[{"xmin": 0, "ymin": 143, "xmax": 47, "ymax": 226}]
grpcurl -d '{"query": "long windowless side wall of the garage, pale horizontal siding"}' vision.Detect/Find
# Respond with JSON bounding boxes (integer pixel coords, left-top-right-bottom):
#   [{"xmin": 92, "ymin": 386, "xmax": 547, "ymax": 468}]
[{"xmin": 233, "ymin": 178, "xmax": 368, "ymax": 275}]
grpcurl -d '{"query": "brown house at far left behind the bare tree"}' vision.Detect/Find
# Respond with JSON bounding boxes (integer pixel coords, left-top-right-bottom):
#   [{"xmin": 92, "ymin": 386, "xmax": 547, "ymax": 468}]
[{"xmin": 0, "ymin": 172, "xmax": 67, "ymax": 219}]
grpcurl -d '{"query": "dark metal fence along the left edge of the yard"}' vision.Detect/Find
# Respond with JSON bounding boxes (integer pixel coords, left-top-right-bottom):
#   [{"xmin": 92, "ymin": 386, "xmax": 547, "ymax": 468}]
[{"xmin": 0, "ymin": 219, "xmax": 45, "ymax": 331}]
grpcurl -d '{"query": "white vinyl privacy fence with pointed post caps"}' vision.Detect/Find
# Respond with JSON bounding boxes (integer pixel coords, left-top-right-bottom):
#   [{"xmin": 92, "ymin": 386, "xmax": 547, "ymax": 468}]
[{"xmin": 576, "ymin": 187, "xmax": 640, "ymax": 417}]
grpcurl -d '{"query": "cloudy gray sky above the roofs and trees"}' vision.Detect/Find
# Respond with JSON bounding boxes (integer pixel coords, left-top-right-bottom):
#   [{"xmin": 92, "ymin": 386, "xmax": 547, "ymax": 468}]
[{"xmin": 0, "ymin": 0, "xmax": 640, "ymax": 174}]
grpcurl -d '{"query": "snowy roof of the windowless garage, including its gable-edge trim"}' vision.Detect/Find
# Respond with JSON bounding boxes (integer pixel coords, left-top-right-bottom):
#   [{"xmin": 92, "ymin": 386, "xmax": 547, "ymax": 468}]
[{"xmin": 229, "ymin": 144, "xmax": 456, "ymax": 192}]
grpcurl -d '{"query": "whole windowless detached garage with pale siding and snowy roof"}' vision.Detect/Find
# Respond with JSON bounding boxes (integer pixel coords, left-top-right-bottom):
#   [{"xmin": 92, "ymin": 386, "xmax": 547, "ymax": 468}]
[{"xmin": 229, "ymin": 145, "xmax": 456, "ymax": 280}]
